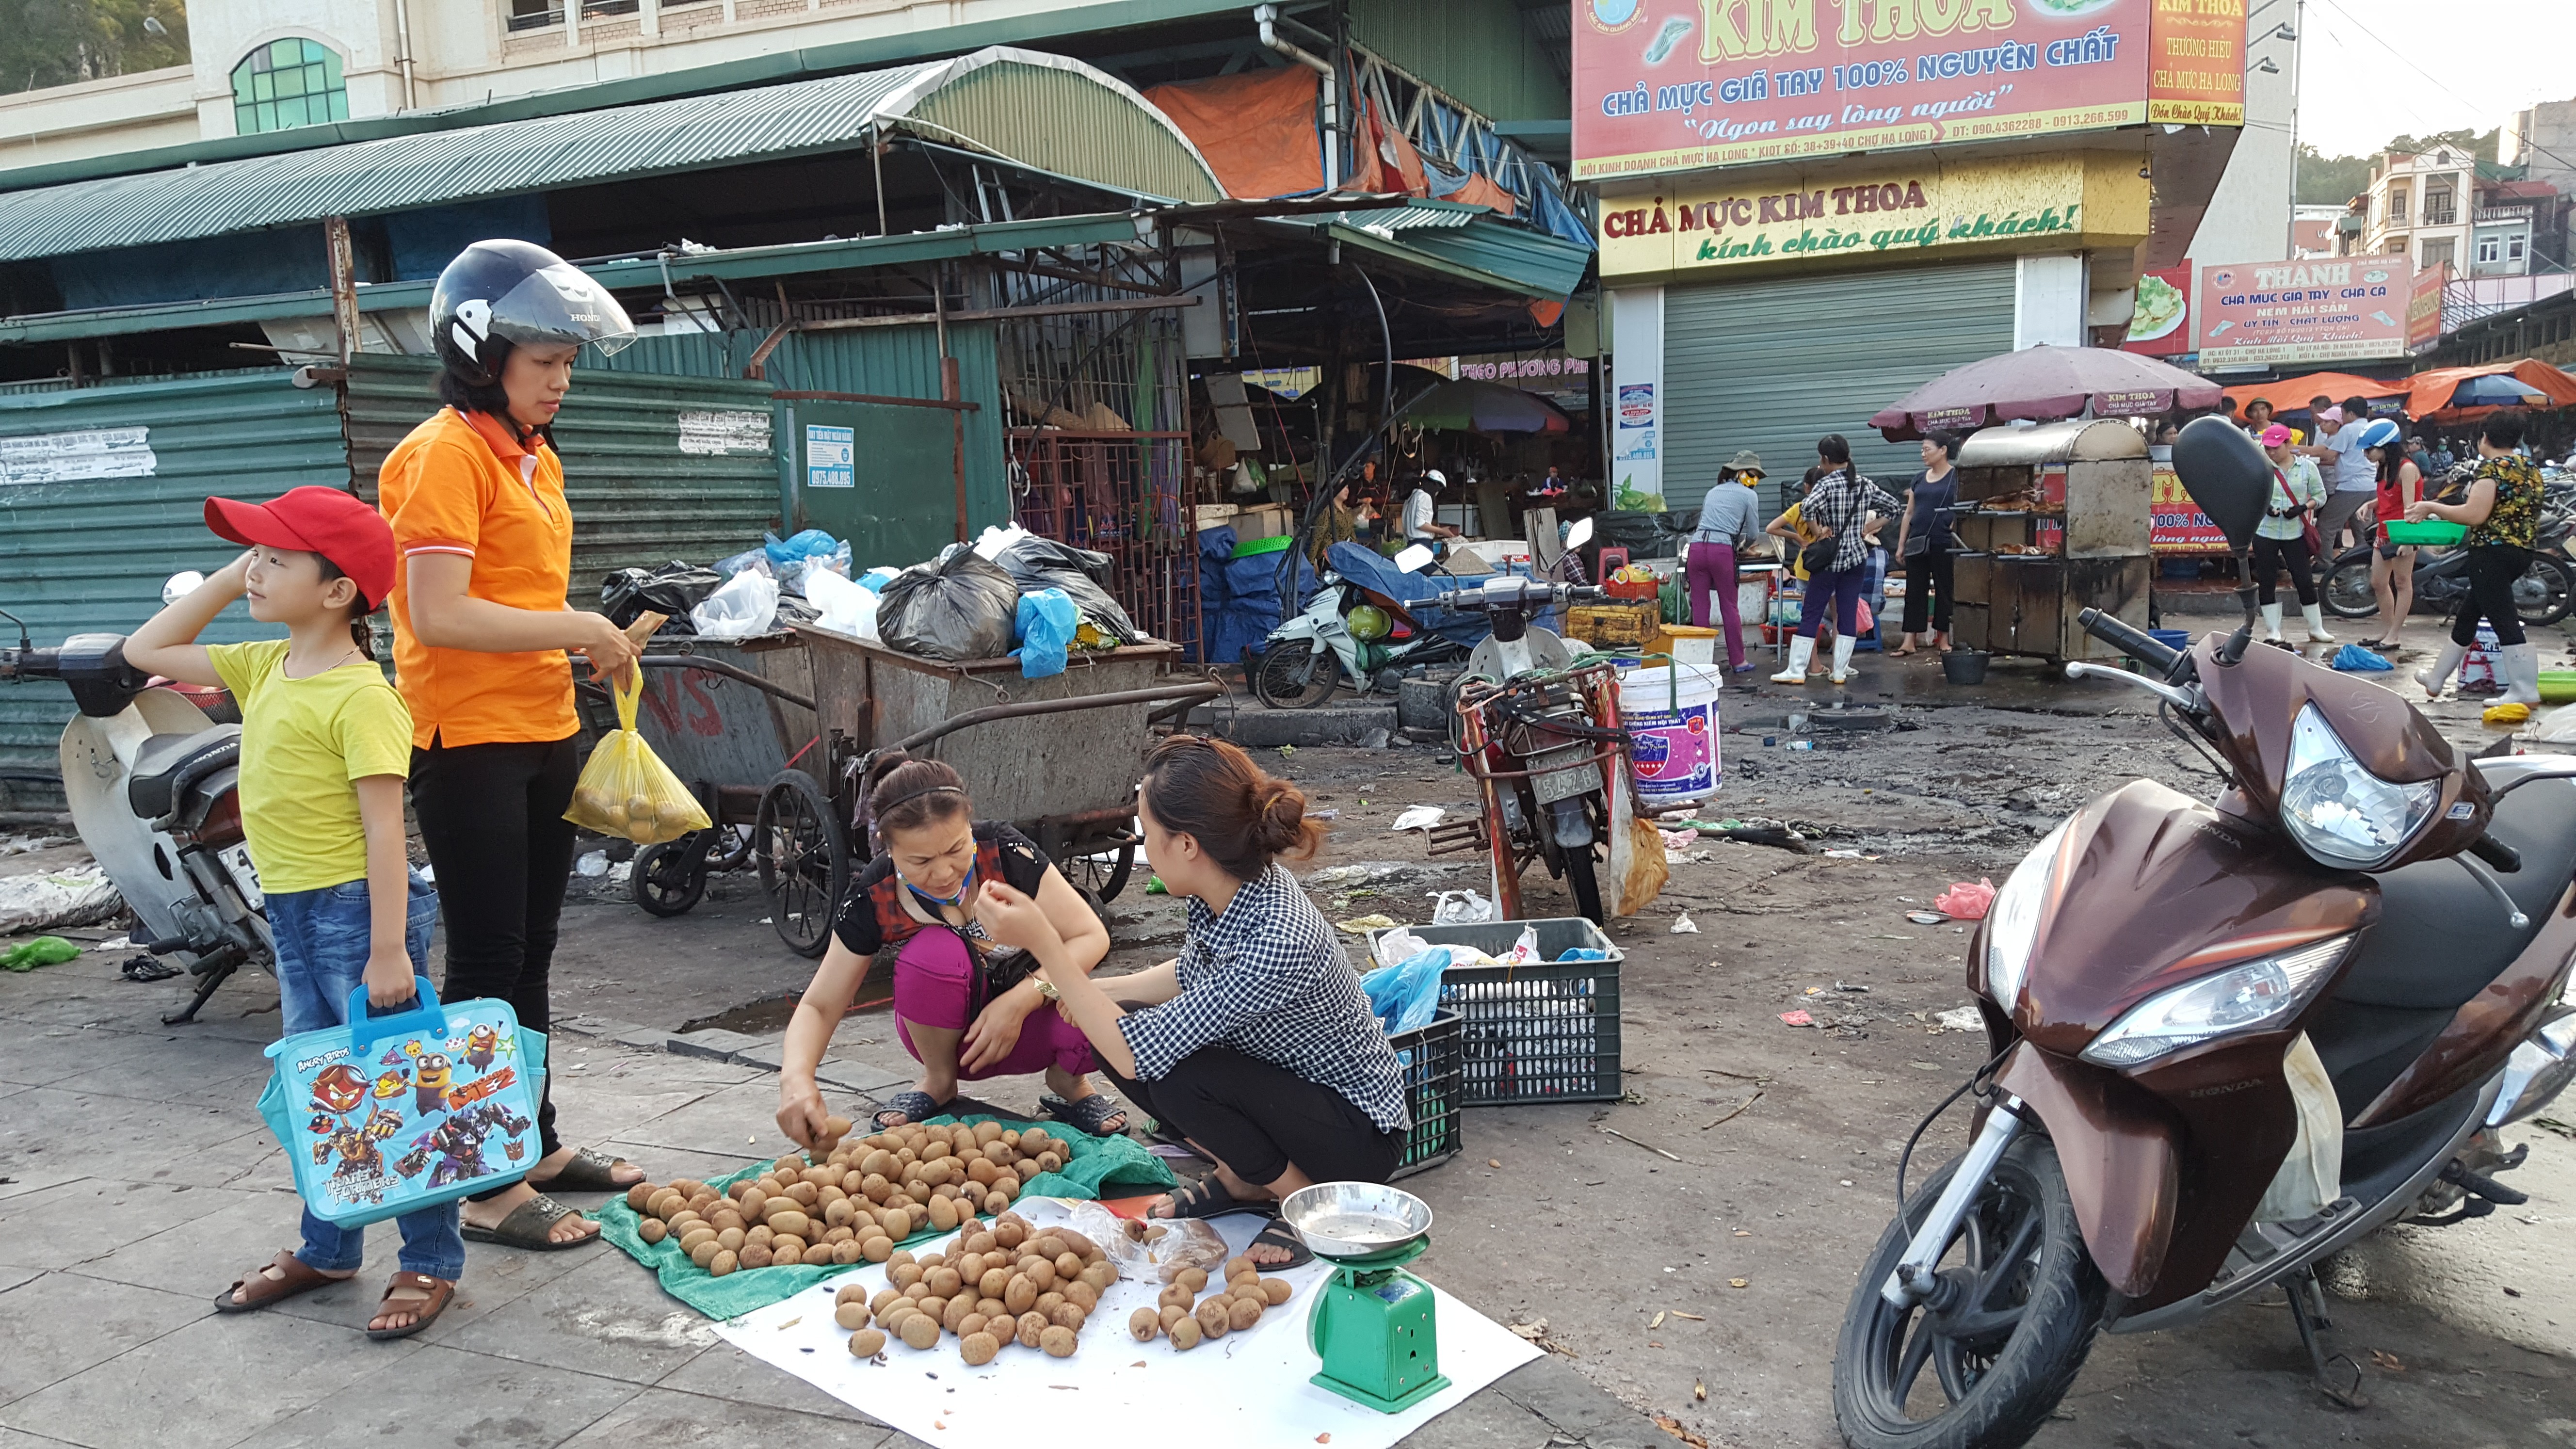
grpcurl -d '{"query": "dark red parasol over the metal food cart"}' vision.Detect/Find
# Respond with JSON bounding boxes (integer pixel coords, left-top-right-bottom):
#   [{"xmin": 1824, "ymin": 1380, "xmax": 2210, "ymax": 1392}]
[{"xmin": 1870, "ymin": 343, "xmax": 2221, "ymax": 443}]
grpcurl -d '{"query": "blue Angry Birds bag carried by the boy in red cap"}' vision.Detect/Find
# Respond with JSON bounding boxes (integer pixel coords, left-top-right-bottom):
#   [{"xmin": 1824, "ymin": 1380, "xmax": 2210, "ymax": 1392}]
[{"xmin": 260, "ymin": 977, "xmax": 546, "ymax": 1227}]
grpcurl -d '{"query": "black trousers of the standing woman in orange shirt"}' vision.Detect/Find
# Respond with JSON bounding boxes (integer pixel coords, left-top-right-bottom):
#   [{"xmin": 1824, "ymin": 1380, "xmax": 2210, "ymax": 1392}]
[{"xmin": 412, "ymin": 740, "xmax": 580, "ymax": 1199}]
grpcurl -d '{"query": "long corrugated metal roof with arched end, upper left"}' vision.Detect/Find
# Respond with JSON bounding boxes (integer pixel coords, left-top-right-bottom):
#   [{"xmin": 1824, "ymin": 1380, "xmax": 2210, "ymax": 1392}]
[{"xmin": 0, "ymin": 47, "xmax": 1224, "ymax": 260}]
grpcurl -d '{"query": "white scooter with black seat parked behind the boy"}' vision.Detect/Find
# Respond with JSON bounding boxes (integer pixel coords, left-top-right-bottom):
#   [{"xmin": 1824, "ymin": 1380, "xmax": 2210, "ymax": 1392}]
[{"xmin": 0, "ymin": 596, "xmax": 275, "ymax": 1026}]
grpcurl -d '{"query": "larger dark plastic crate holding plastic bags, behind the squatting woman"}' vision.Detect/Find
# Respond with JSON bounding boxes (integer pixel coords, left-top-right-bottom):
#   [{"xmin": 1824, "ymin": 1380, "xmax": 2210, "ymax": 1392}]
[{"xmin": 1368, "ymin": 915, "xmax": 1626, "ymax": 1106}]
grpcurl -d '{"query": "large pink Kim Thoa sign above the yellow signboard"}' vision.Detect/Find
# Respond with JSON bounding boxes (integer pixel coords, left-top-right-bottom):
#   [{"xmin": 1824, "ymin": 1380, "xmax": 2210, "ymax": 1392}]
[{"xmin": 1574, "ymin": 0, "xmax": 2246, "ymax": 180}]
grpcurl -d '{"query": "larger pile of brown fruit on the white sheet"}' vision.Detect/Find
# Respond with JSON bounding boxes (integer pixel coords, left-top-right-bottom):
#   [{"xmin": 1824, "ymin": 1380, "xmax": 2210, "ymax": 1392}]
[{"xmin": 832, "ymin": 1212, "xmax": 1118, "ymax": 1367}]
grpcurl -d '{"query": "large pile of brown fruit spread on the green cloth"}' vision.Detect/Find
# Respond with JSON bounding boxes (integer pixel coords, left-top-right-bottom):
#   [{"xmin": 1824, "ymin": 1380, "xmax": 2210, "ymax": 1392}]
[{"xmin": 626, "ymin": 1116, "xmax": 1072, "ymax": 1279}]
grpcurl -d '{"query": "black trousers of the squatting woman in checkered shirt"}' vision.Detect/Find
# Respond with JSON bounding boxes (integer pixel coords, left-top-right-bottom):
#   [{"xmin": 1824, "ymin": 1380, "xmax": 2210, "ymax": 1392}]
[{"xmin": 1103, "ymin": 1047, "xmax": 1404, "ymax": 1183}]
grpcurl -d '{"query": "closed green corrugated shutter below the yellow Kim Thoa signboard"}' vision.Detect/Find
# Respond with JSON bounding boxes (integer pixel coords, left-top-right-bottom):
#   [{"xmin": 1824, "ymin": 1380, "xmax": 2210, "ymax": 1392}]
[{"xmin": 1664, "ymin": 260, "xmax": 2014, "ymax": 508}]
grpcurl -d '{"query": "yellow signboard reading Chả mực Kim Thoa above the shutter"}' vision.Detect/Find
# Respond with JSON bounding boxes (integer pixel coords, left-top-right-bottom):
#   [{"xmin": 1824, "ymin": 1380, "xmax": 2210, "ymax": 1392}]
[{"xmin": 1600, "ymin": 152, "xmax": 2148, "ymax": 278}]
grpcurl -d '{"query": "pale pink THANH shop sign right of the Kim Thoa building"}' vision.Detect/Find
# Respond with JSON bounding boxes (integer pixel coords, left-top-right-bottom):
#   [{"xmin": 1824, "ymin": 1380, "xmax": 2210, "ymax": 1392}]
[{"xmin": 2200, "ymin": 255, "xmax": 2414, "ymax": 371}]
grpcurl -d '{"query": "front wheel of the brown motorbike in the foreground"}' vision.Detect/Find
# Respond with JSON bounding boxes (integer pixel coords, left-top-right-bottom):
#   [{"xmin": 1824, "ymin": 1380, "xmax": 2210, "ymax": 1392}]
[{"xmin": 1834, "ymin": 1132, "xmax": 2110, "ymax": 1449}]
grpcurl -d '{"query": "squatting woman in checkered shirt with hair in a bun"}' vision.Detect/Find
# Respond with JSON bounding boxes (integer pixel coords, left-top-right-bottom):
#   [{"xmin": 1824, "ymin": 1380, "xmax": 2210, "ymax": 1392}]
[{"xmin": 979, "ymin": 735, "xmax": 1414, "ymax": 1266}]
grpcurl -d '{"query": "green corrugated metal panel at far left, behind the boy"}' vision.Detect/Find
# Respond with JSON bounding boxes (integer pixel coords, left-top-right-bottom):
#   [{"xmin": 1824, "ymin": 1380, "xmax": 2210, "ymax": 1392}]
[{"xmin": 0, "ymin": 369, "xmax": 348, "ymax": 773}]
